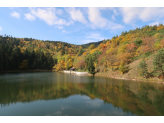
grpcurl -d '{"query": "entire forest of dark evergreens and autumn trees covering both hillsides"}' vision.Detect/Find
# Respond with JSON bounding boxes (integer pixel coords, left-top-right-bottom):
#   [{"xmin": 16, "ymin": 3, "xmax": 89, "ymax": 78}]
[{"xmin": 0, "ymin": 24, "xmax": 164, "ymax": 79}]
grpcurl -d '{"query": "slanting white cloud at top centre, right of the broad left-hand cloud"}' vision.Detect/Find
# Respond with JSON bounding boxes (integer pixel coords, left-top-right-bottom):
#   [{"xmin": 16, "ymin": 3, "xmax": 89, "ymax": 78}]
[{"xmin": 65, "ymin": 7, "xmax": 87, "ymax": 24}]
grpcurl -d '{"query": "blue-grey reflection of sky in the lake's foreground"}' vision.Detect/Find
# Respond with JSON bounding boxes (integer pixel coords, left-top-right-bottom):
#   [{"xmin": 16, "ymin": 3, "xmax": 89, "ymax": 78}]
[{"xmin": 0, "ymin": 95, "xmax": 137, "ymax": 116}]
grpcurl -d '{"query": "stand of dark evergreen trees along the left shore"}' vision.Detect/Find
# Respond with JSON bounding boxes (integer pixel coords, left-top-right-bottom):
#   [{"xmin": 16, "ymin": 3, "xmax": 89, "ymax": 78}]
[{"xmin": 0, "ymin": 43, "xmax": 55, "ymax": 71}]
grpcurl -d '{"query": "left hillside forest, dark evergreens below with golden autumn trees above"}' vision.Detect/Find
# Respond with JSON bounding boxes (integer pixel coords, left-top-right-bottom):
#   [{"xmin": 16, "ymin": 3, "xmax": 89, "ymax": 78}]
[{"xmin": 0, "ymin": 35, "xmax": 78, "ymax": 71}]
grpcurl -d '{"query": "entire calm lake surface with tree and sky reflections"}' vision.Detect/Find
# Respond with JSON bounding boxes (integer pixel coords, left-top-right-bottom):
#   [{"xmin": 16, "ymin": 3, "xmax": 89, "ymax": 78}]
[{"xmin": 0, "ymin": 72, "xmax": 164, "ymax": 116}]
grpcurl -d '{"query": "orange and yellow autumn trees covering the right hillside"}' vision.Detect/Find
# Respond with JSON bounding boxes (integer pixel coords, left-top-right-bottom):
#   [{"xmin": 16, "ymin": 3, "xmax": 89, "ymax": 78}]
[{"xmin": 60, "ymin": 24, "xmax": 164, "ymax": 77}]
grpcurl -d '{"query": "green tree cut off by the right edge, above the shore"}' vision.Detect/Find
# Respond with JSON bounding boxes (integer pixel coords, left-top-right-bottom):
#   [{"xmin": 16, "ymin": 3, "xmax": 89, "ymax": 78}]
[{"xmin": 153, "ymin": 49, "xmax": 164, "ymax": 76}]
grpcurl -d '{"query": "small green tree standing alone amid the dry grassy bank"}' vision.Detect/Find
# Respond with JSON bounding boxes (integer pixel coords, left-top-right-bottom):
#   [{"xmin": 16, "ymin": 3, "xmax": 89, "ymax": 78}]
[{"xmin": 138, "ymin": 59, "xmax": 148, "ymax": 78}]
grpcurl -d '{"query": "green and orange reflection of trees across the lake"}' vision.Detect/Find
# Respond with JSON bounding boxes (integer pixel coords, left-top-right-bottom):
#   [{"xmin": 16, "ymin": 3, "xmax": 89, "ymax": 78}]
[{"xmin": 0, "ymin": 77, "xmax": 164, "ymax": 115}]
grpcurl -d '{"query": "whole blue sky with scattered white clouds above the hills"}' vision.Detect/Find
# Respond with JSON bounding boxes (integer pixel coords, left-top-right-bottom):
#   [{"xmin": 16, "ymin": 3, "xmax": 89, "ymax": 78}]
[{"xmin": 0, "ymin": 7, "xmax": 164, "ymax": 45}]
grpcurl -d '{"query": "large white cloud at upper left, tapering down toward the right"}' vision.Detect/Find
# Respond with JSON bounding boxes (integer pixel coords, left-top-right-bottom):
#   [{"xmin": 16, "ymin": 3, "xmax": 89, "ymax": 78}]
[{"xmin": 26, "ymin": 7, "xmax": 73, "ymax": 26}]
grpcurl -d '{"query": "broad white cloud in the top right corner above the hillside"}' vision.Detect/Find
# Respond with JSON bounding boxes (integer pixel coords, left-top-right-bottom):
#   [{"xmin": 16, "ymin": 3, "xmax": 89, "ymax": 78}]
[{"xmin": 120, "ymin": 7, "xmax": 164, "ymax": 24}]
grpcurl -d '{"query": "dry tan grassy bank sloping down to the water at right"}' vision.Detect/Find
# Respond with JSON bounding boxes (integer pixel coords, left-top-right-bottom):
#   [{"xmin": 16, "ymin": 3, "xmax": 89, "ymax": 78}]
[{"xmin": 95, "ymin": 54, "xmax": 164, "ymax": 83}]
